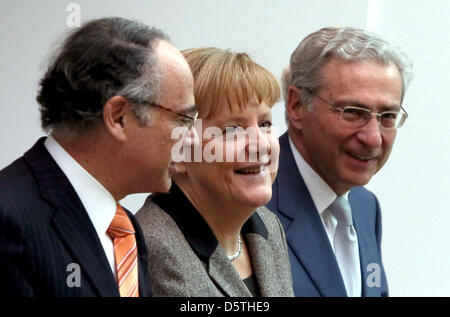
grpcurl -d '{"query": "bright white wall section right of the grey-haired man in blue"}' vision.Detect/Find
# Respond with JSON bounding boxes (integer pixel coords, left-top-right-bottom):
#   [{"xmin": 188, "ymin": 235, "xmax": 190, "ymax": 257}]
[{"xmin": 367, "ymin": 0, "xmax": 450, "ymax": 296}]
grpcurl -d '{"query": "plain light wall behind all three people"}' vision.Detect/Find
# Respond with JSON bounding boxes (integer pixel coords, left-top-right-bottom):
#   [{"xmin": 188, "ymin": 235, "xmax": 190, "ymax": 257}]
[{"xmin": 0, "ymin": 0, "xmax": 450, "ymax": 296}]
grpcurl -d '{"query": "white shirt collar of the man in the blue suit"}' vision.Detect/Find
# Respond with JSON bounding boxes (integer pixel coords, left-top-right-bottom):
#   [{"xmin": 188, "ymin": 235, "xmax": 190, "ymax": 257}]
[{"xmin": 289, "ymin": 137, "xmax": 348, "ymax": 215}]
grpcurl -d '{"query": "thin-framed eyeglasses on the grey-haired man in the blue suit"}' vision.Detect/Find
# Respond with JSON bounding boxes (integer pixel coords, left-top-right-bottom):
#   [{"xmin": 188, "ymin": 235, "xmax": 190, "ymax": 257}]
[{"xmin": 298, "ymin": 87, "xmax": 408, "ymax": 129}]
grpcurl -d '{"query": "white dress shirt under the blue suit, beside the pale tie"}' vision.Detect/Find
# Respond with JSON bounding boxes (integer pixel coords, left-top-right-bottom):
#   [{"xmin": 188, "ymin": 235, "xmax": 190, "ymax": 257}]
[{"xmin": 289, "ymin": 138, "xmax": 348, "ymax": 251}]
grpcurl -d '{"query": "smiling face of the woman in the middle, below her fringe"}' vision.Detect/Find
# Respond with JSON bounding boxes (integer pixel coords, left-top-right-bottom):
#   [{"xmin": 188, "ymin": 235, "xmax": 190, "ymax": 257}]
[{"xmin": 181, "ymin": 102, "xmax": 279, "ymax": 208}]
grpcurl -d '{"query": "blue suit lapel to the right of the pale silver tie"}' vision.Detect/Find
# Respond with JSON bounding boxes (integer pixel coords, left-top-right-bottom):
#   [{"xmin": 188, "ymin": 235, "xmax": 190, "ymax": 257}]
[{"xmin": 349, "ymin": 191, "xmax": 380, "ymax": 297}]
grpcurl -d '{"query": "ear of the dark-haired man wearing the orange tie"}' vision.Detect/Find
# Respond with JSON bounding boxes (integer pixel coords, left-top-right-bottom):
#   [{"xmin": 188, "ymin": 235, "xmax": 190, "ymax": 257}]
[{"xmin": 103, "ymin": 96, "xmax": 133, "ymax": 142}]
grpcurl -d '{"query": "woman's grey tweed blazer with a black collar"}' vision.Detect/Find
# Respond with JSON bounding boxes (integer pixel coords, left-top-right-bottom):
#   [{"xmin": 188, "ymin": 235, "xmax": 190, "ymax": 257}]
[{"xmin": 136, "ymin": 185, "xmax": 293, "ymax": 297}]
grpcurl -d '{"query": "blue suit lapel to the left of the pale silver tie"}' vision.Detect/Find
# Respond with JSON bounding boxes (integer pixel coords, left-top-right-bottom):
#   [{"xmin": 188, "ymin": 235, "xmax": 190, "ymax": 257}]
[{"xmin": 277, "ymin": 133, "xmax": 346, "ymax": 296}]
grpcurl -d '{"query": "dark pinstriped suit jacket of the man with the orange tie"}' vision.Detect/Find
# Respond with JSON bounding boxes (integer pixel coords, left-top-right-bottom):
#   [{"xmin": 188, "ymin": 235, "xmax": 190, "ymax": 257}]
[{"xmin": 0, "ymin": 138, "xmax": 151, "ymax": 296}]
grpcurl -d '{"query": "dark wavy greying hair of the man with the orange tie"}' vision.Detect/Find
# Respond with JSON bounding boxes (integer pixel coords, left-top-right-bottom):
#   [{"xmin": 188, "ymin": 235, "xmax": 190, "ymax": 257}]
[{"xmin": 36, "ymin": 17, "xmax": 168, "ymax": 130}]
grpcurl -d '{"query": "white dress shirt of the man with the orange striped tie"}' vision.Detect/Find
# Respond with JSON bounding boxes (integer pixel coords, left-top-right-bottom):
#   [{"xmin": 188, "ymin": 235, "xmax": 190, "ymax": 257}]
[{"xmin": 44, "ymin": 135, "xmax": 116, "ymax": 276}]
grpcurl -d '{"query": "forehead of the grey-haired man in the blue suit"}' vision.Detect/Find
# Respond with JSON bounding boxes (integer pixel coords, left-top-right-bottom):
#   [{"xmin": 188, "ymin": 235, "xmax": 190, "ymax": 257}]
[{"xmin": 321, "ymin": 58, "xmax": 402, "ymax": 104}]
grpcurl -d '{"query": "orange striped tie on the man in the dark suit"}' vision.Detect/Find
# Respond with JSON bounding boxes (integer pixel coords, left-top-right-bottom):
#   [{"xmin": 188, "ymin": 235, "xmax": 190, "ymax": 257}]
[{"xmin": 107, "ymin": 204, "xmax": 139, "ymax": 297}]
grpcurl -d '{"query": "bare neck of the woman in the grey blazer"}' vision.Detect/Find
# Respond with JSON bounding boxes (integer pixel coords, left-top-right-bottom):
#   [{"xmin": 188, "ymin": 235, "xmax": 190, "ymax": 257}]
[{"xmin": 176, "ymin": 178, "xmax": 256, "ymax": 255}]
